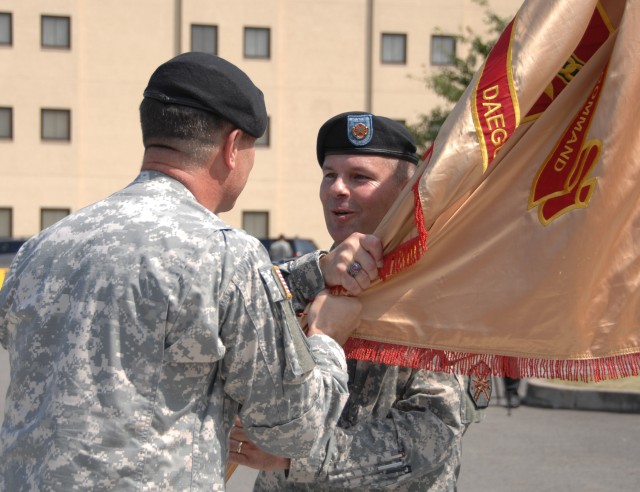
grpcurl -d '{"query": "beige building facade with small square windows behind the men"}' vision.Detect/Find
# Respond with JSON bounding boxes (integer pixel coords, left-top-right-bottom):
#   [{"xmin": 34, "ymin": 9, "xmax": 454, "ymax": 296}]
[{"xmin": 0, "ymin": 0, "xmax": 522, "ymax": 247}]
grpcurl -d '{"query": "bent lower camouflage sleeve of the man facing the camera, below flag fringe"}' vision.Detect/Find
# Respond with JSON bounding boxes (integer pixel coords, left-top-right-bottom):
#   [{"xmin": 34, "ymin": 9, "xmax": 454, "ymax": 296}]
[{"xmin": 287, "ymin": 371, "xmax": 466, "ymax": 490}]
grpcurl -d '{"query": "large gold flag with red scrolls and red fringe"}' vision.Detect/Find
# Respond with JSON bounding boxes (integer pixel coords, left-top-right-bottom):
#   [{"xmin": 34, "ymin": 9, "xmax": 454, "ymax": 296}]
[{"xmin": 345, "ymin": 0, "xmax": 640, "ymax": 381}]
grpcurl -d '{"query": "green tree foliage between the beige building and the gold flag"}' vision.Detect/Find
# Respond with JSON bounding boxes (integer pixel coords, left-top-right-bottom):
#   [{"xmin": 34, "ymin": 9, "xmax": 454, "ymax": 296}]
[{"xmin": 408, "ymin": 0, "xmax": 511, "ymax": 152}]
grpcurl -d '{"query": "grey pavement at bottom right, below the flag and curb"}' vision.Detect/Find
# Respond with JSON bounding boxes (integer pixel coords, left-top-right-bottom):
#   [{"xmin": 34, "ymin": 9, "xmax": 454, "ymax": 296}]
[{"xmin": 459, "ymin": 406, "xmax": 640, "ymax": 492}]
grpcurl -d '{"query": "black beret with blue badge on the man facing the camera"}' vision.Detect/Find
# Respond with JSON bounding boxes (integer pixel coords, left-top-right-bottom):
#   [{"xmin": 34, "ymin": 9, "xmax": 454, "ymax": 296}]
[{"xmin": 316, "ymin": 111, "xmax": 420, "ymax": 167}]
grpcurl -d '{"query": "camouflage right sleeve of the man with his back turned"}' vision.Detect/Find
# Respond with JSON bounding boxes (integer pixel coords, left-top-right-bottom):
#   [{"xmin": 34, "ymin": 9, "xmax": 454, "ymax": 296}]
[{"xmin": 221, "ymin": 248, "xmax": 348, "ymax": 456}]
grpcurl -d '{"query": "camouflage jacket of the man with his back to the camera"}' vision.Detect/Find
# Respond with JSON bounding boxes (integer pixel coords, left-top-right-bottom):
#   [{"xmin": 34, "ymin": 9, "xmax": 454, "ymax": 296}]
[{"xmin": 0, "ymin": 172, "xmax": 347, "ymax": 492}]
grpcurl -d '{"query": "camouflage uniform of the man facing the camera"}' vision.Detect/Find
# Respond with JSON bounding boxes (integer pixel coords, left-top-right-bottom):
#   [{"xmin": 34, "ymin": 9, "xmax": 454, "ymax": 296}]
[{"xmin": 254, "ymin": 257, "xmax": 481, "ymax": 492}]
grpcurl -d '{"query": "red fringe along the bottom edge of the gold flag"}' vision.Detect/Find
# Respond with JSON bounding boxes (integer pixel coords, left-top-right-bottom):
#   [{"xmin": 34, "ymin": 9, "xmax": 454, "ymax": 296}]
[{"xmin": 344, "ymin": 338, "xmax": 640, "ymax": 382}]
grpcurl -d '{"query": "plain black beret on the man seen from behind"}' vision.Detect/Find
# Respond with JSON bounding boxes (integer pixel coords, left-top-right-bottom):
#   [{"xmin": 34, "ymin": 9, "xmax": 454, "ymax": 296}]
[{"xmin": 144, "ymin": 52, "xmax": 267, "ymax": 138}]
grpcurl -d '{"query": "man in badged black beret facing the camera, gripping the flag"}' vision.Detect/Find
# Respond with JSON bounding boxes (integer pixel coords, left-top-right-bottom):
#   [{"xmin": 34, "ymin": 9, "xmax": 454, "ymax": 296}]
[{"xmin": 232, "ymin": 111, "xmax": 472, "ymax": 492}]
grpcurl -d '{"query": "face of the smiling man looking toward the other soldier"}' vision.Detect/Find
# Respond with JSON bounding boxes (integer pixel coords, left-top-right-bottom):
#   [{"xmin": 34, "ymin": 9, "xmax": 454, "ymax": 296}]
[{"xmin": 320, "ymin": 155, "xmax": 404, "ymax": 243}]
